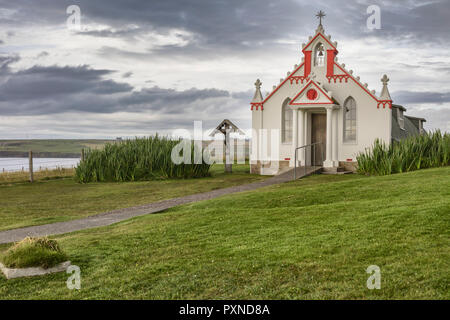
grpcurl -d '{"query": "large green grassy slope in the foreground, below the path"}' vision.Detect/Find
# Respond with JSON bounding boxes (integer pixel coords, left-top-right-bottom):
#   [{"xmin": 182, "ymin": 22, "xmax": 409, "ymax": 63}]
[{"xmin": 0, "ymin": 167, "xmax": 450, "ymax": 299}]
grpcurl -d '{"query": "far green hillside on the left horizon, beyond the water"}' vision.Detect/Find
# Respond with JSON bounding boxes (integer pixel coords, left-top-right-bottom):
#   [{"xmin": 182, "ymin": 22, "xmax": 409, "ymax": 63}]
[{"xmin": 0, "ymin": 139, "xmax": 114, "ymax": 158}]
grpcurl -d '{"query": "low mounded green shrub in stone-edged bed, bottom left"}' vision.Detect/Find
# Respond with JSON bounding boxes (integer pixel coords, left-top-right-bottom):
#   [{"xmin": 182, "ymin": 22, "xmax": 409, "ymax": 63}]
[{"xmin": 0, "ymin": 237, "xmax": 67, "ymax": 269}]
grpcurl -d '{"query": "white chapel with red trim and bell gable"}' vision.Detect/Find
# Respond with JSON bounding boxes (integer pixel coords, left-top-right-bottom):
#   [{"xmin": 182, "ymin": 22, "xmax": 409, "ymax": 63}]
[{"xmin": 250, "ymin": 12, "xmax": 425, "ymax": 175}]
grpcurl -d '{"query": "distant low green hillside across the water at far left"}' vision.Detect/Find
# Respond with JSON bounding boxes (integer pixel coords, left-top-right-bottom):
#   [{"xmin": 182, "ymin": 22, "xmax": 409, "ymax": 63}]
[{"xmin": 0, "ymin": 139, "xmax": 112, "ymax": 154}]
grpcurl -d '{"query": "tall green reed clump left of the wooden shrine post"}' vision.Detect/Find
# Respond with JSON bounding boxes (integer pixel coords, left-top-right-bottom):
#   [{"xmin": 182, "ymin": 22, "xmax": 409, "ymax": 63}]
[{"xmin": 75, "ymin": 135, "xmax": 210, "ymax": 183}]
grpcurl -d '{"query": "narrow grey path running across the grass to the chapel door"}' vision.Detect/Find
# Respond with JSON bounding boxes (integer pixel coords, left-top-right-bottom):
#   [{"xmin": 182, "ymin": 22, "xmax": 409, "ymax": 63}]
[{"xmin": 0, "ymin": 167, "xmax": 315, "ymax": 244}]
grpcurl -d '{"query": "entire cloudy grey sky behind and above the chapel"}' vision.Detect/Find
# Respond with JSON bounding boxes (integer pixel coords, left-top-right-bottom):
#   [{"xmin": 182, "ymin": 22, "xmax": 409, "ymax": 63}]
[{"xmin": 0, "ymin": 0, "xmax": 450, "ymax": 139}]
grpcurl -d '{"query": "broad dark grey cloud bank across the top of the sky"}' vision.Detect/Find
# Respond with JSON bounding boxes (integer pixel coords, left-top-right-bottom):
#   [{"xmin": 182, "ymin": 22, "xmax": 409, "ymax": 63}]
[{"xmin": 0, "ymin": 0, "xmax": 450, "ymax": 54}]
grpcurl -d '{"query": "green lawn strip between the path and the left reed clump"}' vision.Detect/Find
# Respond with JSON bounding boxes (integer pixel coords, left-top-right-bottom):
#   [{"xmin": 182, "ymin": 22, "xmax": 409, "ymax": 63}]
[{"xmin": 0, "ymin": 165, "xmax": 266, "ymax": 230}]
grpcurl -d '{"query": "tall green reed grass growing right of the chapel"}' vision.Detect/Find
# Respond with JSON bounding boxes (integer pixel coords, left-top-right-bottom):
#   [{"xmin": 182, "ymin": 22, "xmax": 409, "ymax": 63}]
[{"xmin": 356, "ymin": 130, "xmax": 450, "ymax": 175}]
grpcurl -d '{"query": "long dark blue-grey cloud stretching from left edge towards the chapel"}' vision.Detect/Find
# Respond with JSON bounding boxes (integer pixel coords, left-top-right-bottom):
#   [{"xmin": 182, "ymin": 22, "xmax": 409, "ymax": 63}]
[{"xmin": 0, "ymin": 61, "xmax": 246, "ymax": 118}]
